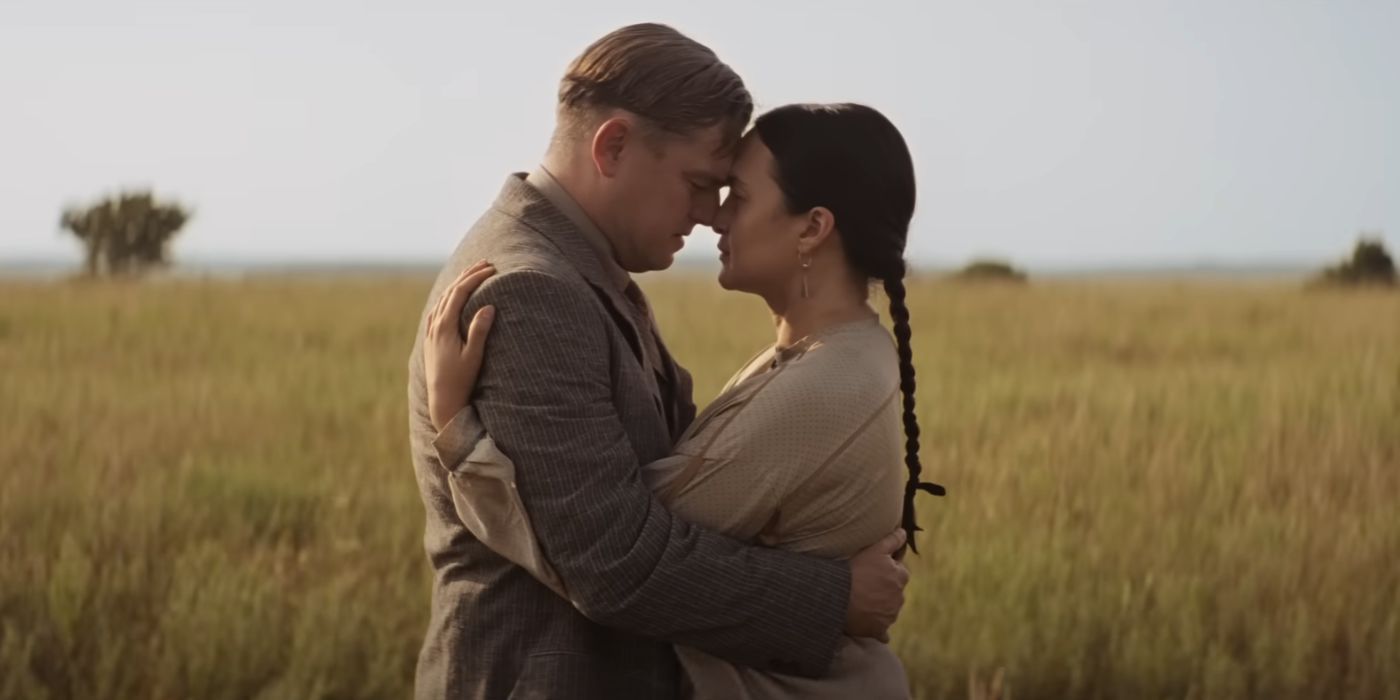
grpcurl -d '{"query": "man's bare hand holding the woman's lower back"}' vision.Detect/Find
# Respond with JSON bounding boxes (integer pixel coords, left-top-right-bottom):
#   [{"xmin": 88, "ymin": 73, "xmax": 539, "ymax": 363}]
[{"xmin": 846, "ymin": 529, "xmax": 909, "ymax": 641}]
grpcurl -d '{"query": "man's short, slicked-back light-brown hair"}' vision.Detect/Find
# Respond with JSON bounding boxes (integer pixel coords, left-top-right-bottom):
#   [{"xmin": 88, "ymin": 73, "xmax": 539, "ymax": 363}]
[{"xmin": 559, "ymin": 24, "xmax": 753, "ymax": 147}]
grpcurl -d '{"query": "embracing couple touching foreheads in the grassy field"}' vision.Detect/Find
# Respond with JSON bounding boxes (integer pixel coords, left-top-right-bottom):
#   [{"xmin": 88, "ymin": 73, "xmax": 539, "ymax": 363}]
[{"xmin": 409, "ymin": 24, "xmax": 942, "ymax": 699}]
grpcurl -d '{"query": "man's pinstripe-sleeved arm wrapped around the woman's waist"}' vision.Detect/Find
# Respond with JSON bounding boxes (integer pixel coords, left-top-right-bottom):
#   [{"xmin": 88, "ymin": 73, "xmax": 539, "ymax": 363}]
[{"xmin": 462, "ymin": 270, "xmax": 850, "ymax": 676}]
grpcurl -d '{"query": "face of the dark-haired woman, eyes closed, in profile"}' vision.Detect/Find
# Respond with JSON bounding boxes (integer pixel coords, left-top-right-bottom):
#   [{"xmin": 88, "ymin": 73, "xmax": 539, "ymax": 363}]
[{"xmin": 713, "ymin": 132, "xmax": 806, "ymax": 301}]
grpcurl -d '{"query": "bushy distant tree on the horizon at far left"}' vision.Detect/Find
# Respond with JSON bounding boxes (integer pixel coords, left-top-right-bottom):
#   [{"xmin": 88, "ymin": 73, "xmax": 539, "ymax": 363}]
[{"xmin": 59, "ymin": 192, "xmax": 190, "ymax": 276}]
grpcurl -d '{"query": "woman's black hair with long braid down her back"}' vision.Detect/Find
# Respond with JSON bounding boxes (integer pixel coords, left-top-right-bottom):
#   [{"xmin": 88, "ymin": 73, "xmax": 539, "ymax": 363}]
[{"xmin": 753, "ymin": 104, "xmax": 944, "ymax": 552}]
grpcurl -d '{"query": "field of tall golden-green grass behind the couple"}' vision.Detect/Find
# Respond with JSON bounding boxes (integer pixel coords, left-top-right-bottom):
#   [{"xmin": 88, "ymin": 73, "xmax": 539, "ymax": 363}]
[{"xmin": 0, "ymin": 277, "xmax": 1400, "ymax": 699}]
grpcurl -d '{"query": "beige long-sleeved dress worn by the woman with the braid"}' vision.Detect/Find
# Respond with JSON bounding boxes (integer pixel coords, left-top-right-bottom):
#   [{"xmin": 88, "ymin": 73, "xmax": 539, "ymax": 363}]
[{"xmin": 440, "ymin": 312, "xmax": 909, "ymax": 699}]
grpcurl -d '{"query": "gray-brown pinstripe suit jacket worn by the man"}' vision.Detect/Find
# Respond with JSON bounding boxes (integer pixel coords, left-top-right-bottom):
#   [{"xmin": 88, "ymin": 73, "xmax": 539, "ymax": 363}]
[{"xmin": 409, "ymin": 175, "xmax": 850, "ymax": 699}]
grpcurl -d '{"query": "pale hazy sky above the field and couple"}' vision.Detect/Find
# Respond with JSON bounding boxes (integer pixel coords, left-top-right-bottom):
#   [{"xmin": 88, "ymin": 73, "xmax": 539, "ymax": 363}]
[{"xmin": 0, "ymin": 0, "xmax": 1400, "ymax": 266}]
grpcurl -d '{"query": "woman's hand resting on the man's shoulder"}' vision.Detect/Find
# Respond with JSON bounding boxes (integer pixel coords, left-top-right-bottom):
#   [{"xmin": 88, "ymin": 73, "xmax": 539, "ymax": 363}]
[{"xmin": 423, "ymin": 260, "xmax": 496, "ymax": 433}]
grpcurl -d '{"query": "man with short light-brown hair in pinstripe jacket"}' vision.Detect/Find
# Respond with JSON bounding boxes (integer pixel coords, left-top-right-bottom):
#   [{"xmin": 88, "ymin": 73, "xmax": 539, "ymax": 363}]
[{"xmin": 409, "ymin": 25, "xmax": 907, "ymax": 699}]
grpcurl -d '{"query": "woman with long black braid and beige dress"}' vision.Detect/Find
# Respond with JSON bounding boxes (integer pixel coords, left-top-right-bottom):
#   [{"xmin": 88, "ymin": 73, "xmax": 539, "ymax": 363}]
[{"xmin": 424, "ymin": 105, "xmax": 942, "ymax": 699}]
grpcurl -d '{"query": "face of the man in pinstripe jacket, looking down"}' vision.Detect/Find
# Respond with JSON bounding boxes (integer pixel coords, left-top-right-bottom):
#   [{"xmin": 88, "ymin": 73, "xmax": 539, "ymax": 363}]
[{"xmin": 609, "ymin": 126, "xmax": 732, "ymax": 273}]
